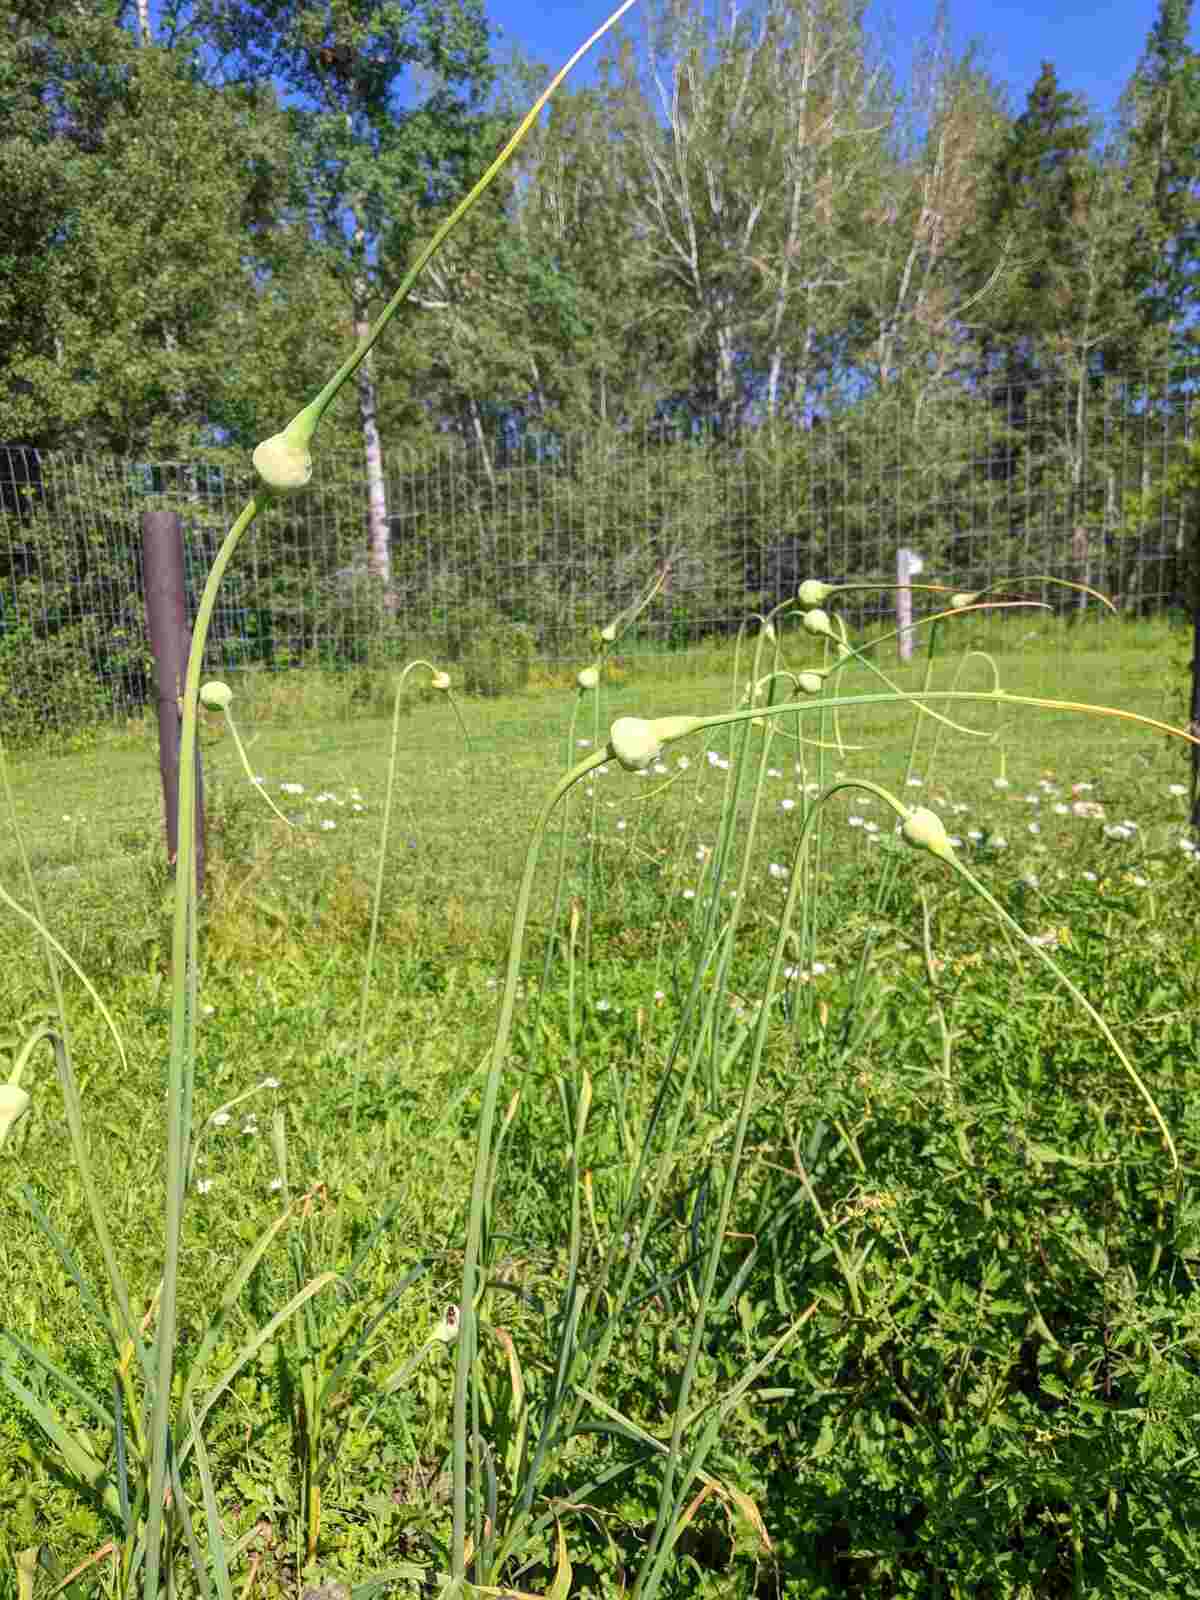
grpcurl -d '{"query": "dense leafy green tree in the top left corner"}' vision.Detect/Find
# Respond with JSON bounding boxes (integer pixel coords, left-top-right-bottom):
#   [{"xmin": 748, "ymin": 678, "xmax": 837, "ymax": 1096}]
[{"xmin": 0, "ymin": 6, "xmax": 285, "ymax": 453}]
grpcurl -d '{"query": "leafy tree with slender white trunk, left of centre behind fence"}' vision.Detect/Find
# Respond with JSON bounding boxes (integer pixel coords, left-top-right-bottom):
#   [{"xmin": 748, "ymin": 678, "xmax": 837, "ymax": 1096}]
[{"xmin": 195, "ymin": 0, "xmax": 493, "ymax": 601}]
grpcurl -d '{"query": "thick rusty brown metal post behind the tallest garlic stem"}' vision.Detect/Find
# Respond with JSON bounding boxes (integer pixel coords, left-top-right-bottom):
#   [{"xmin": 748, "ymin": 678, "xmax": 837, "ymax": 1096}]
[{"xmin": 142, "ymin": 510, "xmax": 205, "ymax": 894}]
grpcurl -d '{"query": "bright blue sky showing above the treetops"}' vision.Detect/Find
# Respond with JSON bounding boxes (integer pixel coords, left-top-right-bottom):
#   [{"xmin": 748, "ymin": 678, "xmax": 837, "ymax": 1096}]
[{"xmin": 486, "ymin": 0, "xmax": 1200, "ymax": 132}]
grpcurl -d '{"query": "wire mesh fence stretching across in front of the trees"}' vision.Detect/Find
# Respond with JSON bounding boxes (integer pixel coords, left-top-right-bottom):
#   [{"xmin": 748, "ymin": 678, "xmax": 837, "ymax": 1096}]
[{"xmin": 0, "ymin": 370, "xmax": 1195, "ymax": 744}]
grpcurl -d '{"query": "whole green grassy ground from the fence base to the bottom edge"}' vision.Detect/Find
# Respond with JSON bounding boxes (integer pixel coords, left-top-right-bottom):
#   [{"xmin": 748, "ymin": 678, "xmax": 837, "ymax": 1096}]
[{"xmin": 0, "ymin": 614, "xmax": 1200, "ymax": 1600}]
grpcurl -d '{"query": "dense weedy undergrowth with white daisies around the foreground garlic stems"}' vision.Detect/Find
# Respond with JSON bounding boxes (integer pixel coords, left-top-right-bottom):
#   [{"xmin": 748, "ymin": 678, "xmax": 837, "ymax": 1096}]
[{"xmin": 0, "ymin": 668, "xmax": 1200, "ymax": 1597}]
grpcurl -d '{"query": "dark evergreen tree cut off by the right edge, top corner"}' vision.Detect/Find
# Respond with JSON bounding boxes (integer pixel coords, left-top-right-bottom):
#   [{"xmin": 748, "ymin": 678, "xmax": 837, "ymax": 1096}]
[{"xmin": 1122, "ymin": 0, "xmax": 1200, "ymax": 355}]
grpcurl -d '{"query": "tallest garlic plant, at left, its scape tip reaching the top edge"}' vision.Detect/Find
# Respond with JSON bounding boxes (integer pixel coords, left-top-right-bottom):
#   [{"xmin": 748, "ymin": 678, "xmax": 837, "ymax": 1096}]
[{"xmin": 0, "ymin": 0, "xmax": 634, "ymax": 1597}]
